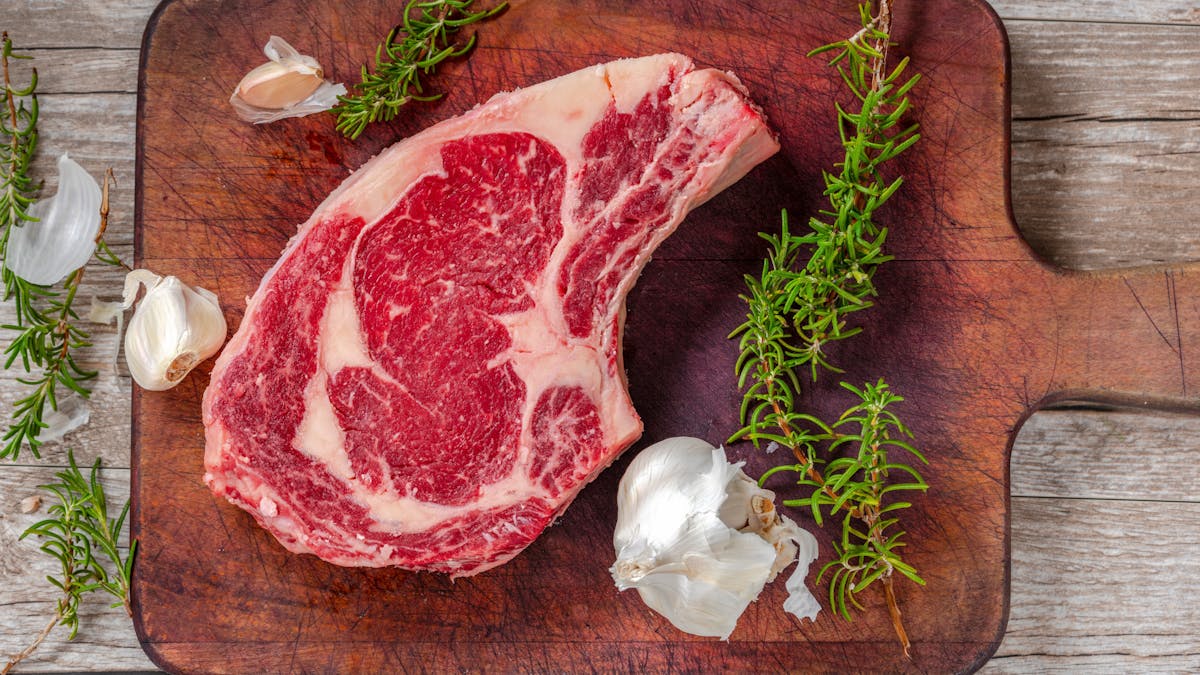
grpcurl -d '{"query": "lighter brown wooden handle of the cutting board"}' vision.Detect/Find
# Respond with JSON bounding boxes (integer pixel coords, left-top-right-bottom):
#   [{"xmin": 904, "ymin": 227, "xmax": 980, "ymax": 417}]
[{"xmin": 1040, "ymin": 264, "xmax": 1200, "ymax": 412}]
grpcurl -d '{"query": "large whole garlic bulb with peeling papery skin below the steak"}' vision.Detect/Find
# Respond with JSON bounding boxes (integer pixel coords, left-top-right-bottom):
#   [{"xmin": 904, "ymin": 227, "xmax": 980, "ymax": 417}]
[{"xmin": 611, "ymin": 437, "xmax": 820, "ymax": 639}]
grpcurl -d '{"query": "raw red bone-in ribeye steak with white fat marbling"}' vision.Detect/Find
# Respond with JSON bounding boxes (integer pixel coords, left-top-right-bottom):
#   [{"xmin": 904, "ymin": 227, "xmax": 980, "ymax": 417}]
[{"xmin": 204, "ymin": 54, "xmax": 779, "ymax": 575}]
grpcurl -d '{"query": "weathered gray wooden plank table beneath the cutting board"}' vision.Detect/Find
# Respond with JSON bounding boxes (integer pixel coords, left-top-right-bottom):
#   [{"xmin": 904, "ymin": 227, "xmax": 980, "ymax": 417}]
[{"xmin": 0, "ymin": 0, "xmax": 1200, "ymax": 671}]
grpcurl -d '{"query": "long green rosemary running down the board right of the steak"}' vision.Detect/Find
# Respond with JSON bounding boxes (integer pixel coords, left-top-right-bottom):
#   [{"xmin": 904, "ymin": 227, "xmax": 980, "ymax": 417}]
[{"xmin": 731, "ymin": 0, "xmax": 928, "ymax": 656}]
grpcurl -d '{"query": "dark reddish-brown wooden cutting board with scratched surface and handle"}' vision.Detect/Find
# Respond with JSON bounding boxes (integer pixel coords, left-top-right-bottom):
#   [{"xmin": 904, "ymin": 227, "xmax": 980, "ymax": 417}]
[{"xmin": 132, "ymin": 0, "xmax": 1200, "ymax": 673}]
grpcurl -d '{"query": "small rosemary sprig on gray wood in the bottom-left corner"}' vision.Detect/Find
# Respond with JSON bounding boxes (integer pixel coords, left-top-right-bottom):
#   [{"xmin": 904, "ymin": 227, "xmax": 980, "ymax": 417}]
[{"xmin": 2, "ymin": 452, "xmax": 138, "ymax": 673}]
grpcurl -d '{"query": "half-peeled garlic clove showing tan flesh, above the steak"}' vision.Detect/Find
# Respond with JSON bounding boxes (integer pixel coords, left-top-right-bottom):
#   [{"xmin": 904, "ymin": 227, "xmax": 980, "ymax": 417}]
[{"xmin": 229, "ymin": 35, "xmax": 346, "ymax": 124}]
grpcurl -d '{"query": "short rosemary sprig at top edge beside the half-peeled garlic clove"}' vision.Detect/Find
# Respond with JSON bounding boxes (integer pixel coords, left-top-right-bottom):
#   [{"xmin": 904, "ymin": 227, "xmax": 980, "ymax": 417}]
[{"xmin": 332, "ymin": 0, "xmax": 508, "ymax": 139}]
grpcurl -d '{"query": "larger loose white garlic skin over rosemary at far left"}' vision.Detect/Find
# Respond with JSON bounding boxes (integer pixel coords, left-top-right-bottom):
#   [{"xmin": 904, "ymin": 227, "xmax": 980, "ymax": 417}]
[{"xmin": 4, "ymin": 154, "xmax": 101, "ymax": 286}]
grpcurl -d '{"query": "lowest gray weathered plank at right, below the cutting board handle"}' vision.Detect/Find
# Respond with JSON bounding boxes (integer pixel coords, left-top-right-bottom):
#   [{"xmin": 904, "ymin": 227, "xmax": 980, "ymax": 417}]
[{"xmin": 985, "ymin": 494, "xmax": 1200, "ymax": 673}]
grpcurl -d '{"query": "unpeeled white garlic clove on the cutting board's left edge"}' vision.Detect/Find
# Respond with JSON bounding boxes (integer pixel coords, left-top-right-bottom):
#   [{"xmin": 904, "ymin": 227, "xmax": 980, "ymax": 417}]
[{"xmin": 124, "ymin": 269, "xmax": 226, "ymax": 392}]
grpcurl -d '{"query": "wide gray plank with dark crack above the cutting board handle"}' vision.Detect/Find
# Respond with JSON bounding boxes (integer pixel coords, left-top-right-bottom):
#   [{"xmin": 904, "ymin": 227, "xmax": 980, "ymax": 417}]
[{"xmin": 1007, "ymin": 22, "xmax": 1200, "ymax": 269}]
